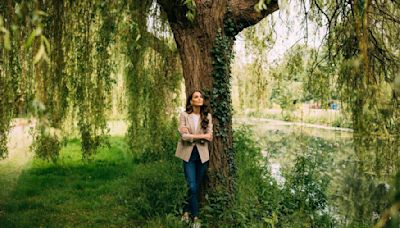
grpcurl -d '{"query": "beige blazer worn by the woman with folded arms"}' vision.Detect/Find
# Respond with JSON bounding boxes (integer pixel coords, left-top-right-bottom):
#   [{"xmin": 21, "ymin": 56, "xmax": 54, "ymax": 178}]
[{"xmin": 175, "ymin": 111, "xmax": 213, "ymax": 163}]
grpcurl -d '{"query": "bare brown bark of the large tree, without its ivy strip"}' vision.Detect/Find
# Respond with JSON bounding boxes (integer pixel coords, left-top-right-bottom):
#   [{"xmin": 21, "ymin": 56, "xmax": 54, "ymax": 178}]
[{"xmin": 158, "ymin": 0, "xmax": 278, "ymax": 194}]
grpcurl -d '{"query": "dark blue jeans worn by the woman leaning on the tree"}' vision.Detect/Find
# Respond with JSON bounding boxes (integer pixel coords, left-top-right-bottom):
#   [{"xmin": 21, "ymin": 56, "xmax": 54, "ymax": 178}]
[{"xmin": 183, "ymin": 146, "xmax": 208, "ymax": 217}]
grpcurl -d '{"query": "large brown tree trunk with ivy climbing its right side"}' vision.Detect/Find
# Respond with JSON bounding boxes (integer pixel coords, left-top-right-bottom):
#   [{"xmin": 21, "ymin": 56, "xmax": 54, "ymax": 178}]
[{"xmin": 157, "ymin": 0, "xmax": 278, "ymax": 190}]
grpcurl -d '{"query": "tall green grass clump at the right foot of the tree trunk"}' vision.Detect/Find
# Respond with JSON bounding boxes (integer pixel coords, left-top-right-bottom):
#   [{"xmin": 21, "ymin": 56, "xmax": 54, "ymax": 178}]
[{"xmin": 203, "ymin": 127, "xmax": 280, "ymax": 227}]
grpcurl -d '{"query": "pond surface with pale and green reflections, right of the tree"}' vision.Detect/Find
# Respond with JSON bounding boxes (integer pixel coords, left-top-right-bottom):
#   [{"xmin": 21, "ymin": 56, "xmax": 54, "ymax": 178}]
[{"xmin": 235, "ymin": 119, "xmax": 399, "ymax": 227}]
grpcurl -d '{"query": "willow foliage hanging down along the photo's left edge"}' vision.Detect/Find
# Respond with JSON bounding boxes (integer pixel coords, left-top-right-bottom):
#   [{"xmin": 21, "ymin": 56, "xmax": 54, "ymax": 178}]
[{"xmin": 0, "ymin": 1, "xmax": 48, "ymax": 158}]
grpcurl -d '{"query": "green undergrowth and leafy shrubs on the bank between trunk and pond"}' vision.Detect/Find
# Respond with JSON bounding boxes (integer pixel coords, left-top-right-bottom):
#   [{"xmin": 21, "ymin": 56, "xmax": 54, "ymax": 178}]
[{"xmin": 203, "ymin": 127, "xmax": 334, "ymax": 227}]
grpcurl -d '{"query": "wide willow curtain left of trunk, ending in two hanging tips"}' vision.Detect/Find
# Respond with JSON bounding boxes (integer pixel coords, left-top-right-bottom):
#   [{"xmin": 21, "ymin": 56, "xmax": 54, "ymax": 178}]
[{"xmin": 29, "ymin": 1, "xmax": 114, "ymax": 161}]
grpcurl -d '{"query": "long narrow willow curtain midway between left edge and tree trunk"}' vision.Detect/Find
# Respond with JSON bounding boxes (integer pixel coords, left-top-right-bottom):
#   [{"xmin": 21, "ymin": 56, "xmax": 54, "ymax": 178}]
[{"xmin": 62, "ymin": 1, "xmax": 115, "ymax": 159}]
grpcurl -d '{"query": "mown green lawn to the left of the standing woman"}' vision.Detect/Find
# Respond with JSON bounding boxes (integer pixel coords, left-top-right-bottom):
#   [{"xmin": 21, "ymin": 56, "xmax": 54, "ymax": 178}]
[{"xmin": 0, "ymin": 138, "xmax": 185, "ymax": 227}]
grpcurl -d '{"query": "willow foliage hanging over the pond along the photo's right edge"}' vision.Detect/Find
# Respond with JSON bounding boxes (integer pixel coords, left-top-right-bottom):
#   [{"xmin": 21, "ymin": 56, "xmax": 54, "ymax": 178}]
[{"xmin": 304, "ymin": 0, "xmax": 400, "ymax": 226}]
